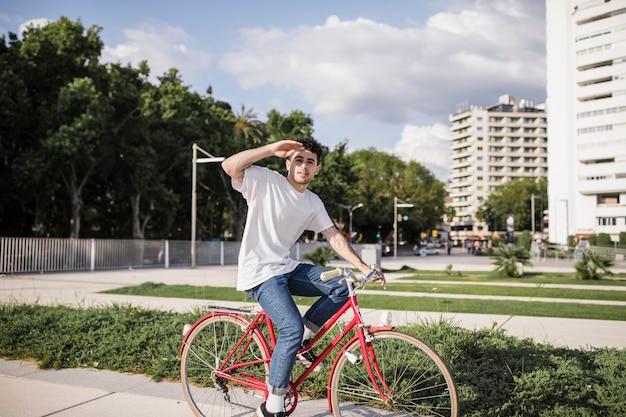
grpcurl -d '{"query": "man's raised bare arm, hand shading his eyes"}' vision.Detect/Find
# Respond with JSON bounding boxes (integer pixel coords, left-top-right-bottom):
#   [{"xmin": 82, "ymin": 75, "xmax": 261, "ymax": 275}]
[{"xmin": 222, "ymin": 140, "xmax": 304, "ymax": 182}]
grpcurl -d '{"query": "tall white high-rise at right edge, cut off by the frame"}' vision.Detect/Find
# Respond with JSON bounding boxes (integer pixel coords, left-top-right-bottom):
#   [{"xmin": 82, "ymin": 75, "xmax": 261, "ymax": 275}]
[{"xmin": 546, "ymin": 0, "xmax": 626, "ymax": 243}]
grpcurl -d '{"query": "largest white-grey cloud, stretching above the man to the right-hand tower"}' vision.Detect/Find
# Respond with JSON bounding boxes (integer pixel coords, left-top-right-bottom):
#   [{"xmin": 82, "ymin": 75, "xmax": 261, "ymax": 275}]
[{"xmin": 221, "ymin": 0, "xmax": 545, "ymax": 123}]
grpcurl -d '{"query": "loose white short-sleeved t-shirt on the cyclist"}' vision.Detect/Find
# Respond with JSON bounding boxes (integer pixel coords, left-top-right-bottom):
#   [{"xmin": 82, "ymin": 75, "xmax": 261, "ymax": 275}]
[{"xmin": 231, "ymin": 165, "xmax": 334, "ymax": 291}]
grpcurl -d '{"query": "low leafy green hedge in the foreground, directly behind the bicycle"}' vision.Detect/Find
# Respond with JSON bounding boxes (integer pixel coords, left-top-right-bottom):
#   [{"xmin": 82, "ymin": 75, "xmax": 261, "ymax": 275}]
[{"xmin": 0, "ymin": 304, "xmax": 626, "ymax": 417}]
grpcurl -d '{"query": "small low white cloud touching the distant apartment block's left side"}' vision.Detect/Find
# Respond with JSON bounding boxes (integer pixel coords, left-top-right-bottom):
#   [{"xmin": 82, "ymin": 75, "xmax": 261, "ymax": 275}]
[{"xmin": 387, "ymin": 123, "xmax": 450, "ymax": 182}]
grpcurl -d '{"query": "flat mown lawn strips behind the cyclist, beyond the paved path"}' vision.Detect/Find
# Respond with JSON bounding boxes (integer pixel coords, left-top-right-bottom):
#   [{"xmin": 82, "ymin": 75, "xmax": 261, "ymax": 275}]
[{"xmin": 106, "ymin": 264, "xmax": 626, "ymax": 321}]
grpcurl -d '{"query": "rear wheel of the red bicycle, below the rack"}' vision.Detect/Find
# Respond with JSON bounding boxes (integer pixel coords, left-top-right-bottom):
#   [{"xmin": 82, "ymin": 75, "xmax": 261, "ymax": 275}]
[{"xmin": 180, "ymin": 313, "xmax": 269, "ymax": 417}]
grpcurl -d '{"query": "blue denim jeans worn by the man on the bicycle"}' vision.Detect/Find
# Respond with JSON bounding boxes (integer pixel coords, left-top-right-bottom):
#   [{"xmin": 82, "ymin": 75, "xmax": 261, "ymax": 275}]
[{"xmin": 246, "ymin": 264, "xmax": 348, "ymax": 395}]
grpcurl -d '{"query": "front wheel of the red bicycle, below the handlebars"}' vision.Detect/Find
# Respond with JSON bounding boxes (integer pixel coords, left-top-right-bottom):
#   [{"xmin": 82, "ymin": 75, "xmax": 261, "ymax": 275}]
[{"xmin": 329, "ymin": 330, "xmax": 459, "ymax": 417}]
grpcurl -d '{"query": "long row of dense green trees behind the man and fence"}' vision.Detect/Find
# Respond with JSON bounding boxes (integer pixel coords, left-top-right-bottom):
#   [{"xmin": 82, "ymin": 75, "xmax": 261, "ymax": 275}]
[{"xmin": 0, "ymin": 17, "xmax": 446, "ymax": 241}]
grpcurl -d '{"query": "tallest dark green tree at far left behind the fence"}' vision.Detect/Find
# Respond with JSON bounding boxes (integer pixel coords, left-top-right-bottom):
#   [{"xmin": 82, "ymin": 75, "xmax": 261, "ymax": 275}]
[{"xmin": 13, "ymin": 17, "xmax": 104, "ymax": 237}]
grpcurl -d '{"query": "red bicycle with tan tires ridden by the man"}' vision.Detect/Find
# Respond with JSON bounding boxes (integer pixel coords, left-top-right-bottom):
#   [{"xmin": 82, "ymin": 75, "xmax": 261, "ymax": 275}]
[{"xmin": 180, "ymin": 269, "xmax": 459, "ymax": 417}]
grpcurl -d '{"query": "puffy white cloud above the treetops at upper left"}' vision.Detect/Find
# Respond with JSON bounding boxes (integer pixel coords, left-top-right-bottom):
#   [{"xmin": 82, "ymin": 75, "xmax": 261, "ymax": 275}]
[{"xmin": 102, "ymin": 20, "xmax": 211, "ymax": 84}]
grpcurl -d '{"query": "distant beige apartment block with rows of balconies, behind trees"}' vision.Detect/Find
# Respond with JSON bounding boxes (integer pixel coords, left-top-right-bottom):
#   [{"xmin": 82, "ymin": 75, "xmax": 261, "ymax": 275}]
[{"xmin": 446, "ymin": 95, "xmax": 548, "ymax": 240}]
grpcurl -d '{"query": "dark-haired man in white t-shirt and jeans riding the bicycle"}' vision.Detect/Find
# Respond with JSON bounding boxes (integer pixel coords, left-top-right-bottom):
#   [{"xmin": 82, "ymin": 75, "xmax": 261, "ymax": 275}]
[{"xmin": 222, "ymin": 139, "xmax": 385, "ymax": 417}]
